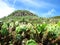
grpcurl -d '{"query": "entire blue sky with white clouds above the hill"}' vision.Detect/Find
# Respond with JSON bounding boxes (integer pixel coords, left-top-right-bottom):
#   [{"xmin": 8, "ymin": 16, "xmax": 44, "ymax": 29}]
[{"xmin": 0, "ymin": 0, "xmax": 60, "ymax": 18}]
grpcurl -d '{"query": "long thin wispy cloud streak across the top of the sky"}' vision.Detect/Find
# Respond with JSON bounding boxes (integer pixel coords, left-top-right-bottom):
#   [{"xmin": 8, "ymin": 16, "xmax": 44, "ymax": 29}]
[{"xmin": 16, "ymin": 0, "xmax": 55, "ymax": 8}]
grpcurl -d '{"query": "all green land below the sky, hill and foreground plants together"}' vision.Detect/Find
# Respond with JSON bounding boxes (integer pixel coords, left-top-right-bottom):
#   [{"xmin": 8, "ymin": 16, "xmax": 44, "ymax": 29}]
[{"xmin": 0, "ymin": 10, "xmax": 60, "ymax": 45}]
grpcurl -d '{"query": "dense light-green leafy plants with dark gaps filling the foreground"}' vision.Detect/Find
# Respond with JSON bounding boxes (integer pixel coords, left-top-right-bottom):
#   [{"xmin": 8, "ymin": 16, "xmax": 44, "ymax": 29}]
[{"xmin": 0, "ymin": 21, "xmax": 60, "ymax": 45}]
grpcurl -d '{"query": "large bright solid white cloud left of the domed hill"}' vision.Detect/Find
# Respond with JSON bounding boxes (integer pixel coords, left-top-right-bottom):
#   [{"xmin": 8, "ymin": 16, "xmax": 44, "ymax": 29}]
[{"xmin": 0, "ymin": 0, "xmax": 15, "ymax": 18}]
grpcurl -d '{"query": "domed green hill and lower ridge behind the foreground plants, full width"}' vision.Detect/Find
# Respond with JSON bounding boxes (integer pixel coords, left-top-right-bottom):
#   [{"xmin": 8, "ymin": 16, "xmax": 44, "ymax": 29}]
[{"xmin": 0, "ymin": 10, "xmax": 60, "ymax": 23}]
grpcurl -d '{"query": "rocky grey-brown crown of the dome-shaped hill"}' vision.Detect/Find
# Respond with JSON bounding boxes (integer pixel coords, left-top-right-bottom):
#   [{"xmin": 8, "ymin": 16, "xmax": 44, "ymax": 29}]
[{"xmin": 9, "ymin": 10, "xmax": 37, "ymax": 16}]
